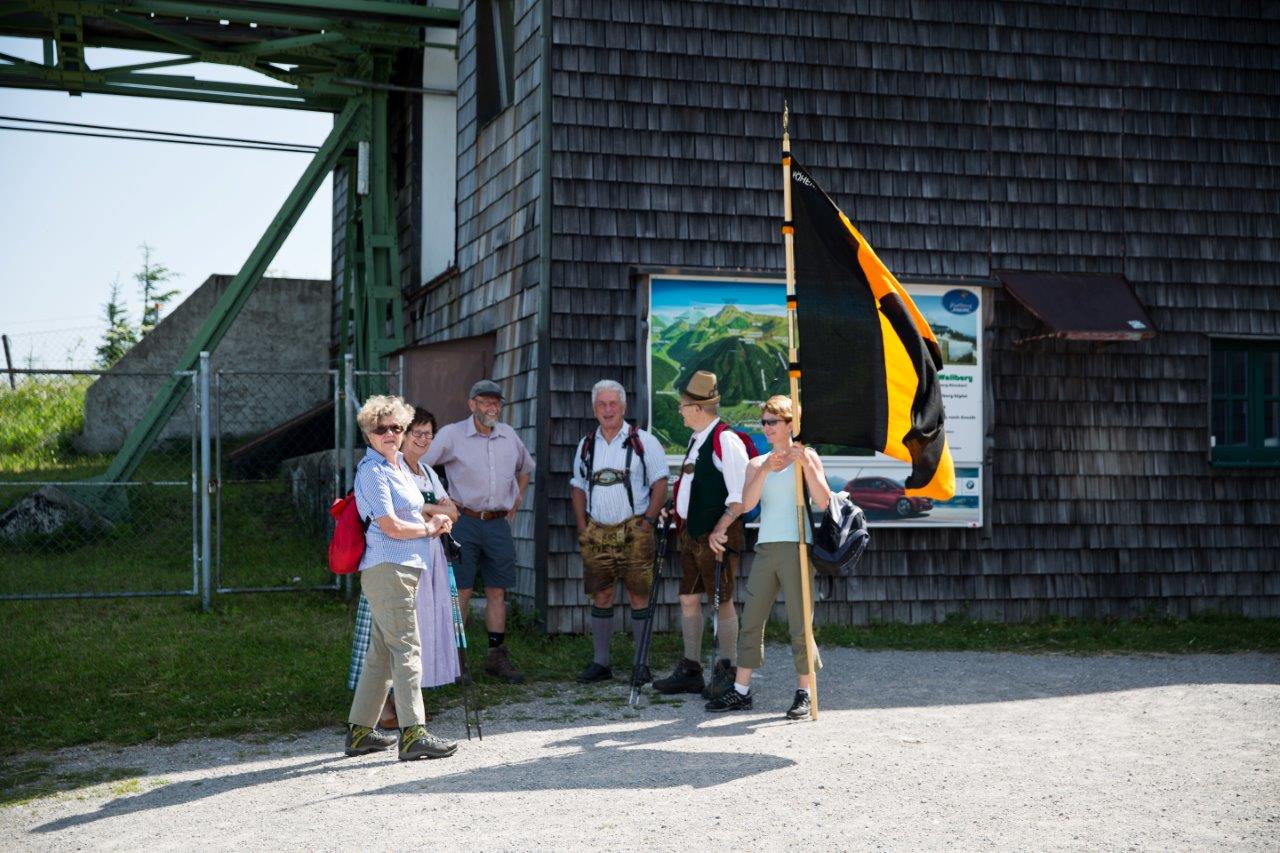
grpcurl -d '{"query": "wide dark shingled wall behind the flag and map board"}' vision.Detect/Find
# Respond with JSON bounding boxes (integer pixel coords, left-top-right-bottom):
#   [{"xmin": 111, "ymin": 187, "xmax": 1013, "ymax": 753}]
[{"xmin": 542, "ymin": 0, "xmax": 1280, "ymax": 631}]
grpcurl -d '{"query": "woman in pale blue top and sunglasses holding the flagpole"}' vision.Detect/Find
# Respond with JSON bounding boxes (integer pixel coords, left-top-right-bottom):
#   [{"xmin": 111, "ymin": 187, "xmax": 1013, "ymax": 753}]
[{"xmin": 705, "ymin": 394, "xmax": 831, "ymax": 720}]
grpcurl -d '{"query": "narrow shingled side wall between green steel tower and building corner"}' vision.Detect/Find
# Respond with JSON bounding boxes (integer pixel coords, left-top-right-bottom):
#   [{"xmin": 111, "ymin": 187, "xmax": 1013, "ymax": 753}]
[{"xmin": 406, "ymin": 0, "xmax": 545, "ymax": 606}]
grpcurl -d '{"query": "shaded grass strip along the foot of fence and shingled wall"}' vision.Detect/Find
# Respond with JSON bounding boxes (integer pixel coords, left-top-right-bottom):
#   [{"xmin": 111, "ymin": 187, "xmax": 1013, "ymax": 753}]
[{"xmin": 0, "ymin": 593, "xmax": 1280, "ymax": 753}]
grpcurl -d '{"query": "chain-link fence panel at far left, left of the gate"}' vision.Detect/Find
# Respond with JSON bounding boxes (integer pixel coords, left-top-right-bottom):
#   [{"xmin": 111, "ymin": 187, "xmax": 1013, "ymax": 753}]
[{"xmin": 0, "ymin": 369, "xmax": 198, "ymax": 598}]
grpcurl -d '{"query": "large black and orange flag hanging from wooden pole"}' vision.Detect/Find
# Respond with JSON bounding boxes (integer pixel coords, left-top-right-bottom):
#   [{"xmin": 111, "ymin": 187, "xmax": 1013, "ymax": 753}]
[{"xmin": 791, "ymin": 158, "xmax": 956, "ymax": 501}]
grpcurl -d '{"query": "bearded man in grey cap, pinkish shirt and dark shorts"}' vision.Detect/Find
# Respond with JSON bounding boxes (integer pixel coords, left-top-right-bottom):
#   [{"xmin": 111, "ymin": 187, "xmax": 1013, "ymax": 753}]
[{"xmin": 422, "ymin": 379, "xmax": 534, "ymax": 684}]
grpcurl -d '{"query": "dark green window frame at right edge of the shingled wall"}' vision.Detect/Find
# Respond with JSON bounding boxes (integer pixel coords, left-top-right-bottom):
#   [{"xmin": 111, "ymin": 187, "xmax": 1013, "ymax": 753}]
[{"xmin": 1207, "ymin": 337, "xmax": 1280, "ymax": 467}]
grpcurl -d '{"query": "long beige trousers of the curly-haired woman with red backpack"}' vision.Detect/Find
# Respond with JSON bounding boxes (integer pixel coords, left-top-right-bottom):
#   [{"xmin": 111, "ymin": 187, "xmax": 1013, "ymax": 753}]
[{"xmin": 347, "ymin": 562, "xmax": 426, "ymax": 729}]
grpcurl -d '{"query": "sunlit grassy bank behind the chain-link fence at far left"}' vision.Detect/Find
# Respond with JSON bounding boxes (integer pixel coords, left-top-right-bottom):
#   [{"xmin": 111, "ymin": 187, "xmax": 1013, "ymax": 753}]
[{"xmin": 0, "ymin": 377, "xmax": 92, "ymax": 471}]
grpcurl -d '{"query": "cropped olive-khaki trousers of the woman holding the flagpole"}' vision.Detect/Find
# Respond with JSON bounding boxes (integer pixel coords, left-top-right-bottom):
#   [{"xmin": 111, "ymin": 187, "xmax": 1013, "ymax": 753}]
[{"xmin": 737, "ymin": 542, "xmax": 822, "ymax": 675}]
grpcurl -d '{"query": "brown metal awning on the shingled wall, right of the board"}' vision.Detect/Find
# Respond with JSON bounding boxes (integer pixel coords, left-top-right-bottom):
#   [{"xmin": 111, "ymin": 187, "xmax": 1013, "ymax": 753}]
[{"xmin": 995, "ymin": 270, "xmax": 1156, "ymax": 343}]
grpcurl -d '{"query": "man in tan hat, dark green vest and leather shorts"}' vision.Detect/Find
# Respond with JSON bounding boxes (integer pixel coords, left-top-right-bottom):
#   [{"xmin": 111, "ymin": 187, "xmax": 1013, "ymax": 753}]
[{"xmin": 653, "ymin": 370, "xmax": 748, "ymax": 698}]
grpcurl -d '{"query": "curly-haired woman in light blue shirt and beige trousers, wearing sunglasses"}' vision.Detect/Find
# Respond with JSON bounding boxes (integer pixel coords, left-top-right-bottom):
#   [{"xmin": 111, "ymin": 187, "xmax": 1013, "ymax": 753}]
[{"xmin": 346, "ymin": 396, "xmax": 458, "ymax": 761}]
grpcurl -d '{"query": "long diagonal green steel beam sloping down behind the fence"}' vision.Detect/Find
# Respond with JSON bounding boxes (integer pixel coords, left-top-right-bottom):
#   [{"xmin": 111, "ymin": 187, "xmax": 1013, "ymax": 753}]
[{"xmin": 99, "ymin": 99, "xmax": 367, "ymax": 483}]
